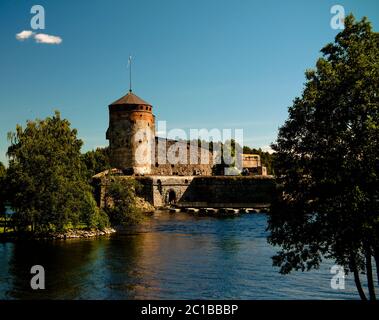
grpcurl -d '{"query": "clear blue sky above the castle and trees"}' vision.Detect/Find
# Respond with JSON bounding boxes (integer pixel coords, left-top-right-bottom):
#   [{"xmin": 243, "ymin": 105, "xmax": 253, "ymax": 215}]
[{"xmin": 0, "ymin": 0, "xmax": 379, "ymax": 162}]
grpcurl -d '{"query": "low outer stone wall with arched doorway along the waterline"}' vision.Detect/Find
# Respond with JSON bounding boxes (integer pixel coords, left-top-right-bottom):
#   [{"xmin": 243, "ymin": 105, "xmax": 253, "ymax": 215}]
[{"xmin": 137, "ymin": 176, "xmax": 275, "ymax": 207}]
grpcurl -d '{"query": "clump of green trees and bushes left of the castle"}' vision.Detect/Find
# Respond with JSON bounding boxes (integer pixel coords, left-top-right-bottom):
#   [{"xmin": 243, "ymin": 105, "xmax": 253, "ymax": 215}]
[{"xmin": 0, "ymin": 112, "xmax": 139, "ymax": 233}]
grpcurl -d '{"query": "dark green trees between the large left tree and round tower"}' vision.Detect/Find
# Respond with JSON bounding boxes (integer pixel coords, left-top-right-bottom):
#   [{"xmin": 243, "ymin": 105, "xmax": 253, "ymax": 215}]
[{"xmin": 82, "ymin": 148, "xmax": 111, "ymax": 180}]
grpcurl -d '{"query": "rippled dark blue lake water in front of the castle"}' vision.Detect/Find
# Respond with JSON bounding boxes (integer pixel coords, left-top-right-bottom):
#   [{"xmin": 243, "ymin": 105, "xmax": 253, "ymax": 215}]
[{"xmin": 0, "ymin": 212, "xmax": 359, "ymax": 299}]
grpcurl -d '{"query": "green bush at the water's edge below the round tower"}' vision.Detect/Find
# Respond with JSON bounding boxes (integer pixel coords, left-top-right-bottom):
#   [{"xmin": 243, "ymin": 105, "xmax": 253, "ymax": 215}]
[{"xmin": 105, "ymin": 177, "xmax": 143, "ymax": 226}]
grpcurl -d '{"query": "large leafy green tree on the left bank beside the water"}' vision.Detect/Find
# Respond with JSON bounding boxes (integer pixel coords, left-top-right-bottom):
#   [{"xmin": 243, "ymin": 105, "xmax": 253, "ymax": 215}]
[{"xmin": 7, "ymin": 112, "xmax": 108, "ymax": 232}]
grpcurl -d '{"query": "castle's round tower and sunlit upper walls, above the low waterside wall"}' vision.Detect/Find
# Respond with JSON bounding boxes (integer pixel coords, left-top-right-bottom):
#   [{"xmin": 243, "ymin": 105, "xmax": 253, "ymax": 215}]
[{"xmin": 106, "ymin": 90, "xmax": 266, "ymax": 176}]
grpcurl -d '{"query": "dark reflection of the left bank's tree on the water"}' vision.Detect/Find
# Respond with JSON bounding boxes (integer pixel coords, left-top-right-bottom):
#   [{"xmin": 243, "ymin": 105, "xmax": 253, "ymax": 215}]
[{"xmin": 8, "ymin": 240, "xmax": 104, "ymax": 299}]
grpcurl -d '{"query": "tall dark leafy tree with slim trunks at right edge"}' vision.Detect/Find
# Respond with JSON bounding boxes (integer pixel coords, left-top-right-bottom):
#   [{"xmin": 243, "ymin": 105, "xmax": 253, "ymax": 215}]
[{"xmin": 268, "ymin": 15, "xmax": 379, "ymax": 299}]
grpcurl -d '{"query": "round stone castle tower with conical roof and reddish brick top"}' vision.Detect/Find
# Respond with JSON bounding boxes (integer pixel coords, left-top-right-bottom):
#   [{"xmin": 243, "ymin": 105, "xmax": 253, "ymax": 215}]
[{"xmin": 106, "ymin": 90, "xmax": 155, "ymax": 174}]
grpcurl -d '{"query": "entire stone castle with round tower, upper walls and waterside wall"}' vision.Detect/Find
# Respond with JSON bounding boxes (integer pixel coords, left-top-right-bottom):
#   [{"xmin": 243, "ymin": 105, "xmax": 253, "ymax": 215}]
[{"xmin": 93, "ymin": 90, "xmax": 275, "ymax": 208}]
